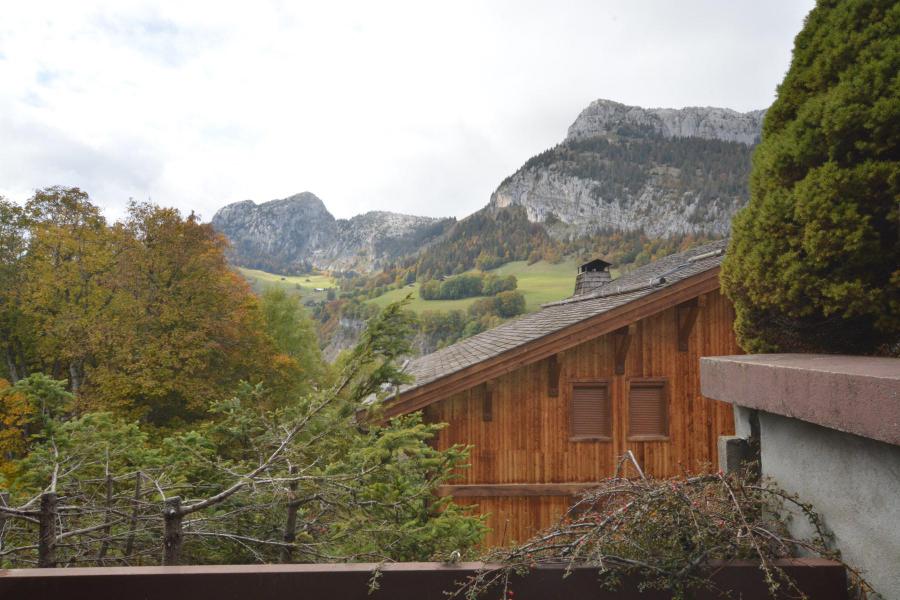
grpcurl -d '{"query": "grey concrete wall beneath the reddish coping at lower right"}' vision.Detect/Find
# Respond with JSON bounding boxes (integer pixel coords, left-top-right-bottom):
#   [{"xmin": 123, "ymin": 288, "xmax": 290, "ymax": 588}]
[{"xmin": 735, "ymin": 409, "xmax": 900, "ymax": 600}]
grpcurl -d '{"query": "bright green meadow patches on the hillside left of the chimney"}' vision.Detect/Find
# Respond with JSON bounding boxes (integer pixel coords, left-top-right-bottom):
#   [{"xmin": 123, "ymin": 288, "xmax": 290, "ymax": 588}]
[{"xmin": 369, "ymin": 260, "xmax": 578, "ymax": 312}]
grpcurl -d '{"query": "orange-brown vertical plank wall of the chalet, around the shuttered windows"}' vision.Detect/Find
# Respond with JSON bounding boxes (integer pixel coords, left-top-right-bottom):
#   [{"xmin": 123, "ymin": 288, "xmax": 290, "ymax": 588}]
[{"xmin": 425, "ymin": 291, "xmax": 740, "ymax": 546}]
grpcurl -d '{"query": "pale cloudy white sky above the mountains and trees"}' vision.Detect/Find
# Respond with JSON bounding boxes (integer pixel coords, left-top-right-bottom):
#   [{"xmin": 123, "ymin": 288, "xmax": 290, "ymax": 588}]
[{"xmin": 0, "ymin": 0, "xmax": 813, "ymax": 219}]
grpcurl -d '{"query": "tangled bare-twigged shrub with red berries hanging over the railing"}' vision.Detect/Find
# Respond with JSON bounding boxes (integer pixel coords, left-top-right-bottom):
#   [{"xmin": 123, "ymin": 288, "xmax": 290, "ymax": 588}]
[{"xmin": 456, "ymin": 473, "xmax": 872, "ymax": 599}]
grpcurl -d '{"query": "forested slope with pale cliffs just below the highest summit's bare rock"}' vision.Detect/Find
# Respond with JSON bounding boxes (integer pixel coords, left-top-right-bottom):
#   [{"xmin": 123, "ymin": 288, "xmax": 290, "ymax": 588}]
[{"xmin": 490, "ymin": 119, "xmax": 753, "ymax": 239}]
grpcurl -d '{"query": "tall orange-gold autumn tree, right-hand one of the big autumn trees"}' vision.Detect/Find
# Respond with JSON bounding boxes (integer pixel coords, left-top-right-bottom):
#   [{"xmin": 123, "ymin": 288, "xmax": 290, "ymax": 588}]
[{"xmin": 88, "ymin": 204, "xmax": 279, "ymax": 424}]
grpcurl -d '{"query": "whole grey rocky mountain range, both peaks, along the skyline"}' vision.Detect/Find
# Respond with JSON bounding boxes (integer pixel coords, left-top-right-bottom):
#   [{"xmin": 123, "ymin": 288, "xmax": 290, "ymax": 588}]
[{"xmin": 212, "ymin": 100, "xmax": 765, "ymax": 278}]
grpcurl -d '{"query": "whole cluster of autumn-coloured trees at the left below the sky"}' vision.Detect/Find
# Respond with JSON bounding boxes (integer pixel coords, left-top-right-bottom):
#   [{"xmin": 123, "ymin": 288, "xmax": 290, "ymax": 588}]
[{"xmin": 0, "ymin": 187, "xmax": 325, "ymax": 426}]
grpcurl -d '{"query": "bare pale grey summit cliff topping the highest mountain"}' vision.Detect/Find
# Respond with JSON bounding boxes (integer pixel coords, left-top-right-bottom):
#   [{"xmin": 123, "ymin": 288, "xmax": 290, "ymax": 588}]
[{"xmin": 566, "ymin": 100, "xmax": 766, "ymax": 146}]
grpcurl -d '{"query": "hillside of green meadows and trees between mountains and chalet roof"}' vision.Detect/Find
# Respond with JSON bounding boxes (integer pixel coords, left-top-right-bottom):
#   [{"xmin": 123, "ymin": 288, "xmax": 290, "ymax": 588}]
[{"xmin": 302, "ymin": 229, "xmax": 714, "ymax": 358}]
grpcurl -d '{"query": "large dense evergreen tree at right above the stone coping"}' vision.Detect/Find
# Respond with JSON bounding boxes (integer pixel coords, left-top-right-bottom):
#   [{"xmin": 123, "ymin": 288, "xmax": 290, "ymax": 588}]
[{"xmin": 722, "ymin": 0, "xmax": 900, "ymax": 353}]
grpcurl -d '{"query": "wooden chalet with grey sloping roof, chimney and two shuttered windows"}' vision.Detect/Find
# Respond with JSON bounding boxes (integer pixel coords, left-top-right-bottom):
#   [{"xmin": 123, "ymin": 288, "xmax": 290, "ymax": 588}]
[{"xmin": 385, "ymin": 242, "xmax": 740, "ymax": 545}]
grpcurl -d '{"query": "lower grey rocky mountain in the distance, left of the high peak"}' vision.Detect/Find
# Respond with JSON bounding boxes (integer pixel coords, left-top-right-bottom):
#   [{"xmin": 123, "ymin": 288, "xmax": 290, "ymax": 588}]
[{"xmin": 212, "ymin": 192, "xmax": 455, "ymax": 273}]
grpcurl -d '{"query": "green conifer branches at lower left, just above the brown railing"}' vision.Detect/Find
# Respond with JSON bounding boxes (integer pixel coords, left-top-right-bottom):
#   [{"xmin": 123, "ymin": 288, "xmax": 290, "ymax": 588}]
[{"xmin": 0, "ymin": 298, "xmax": 485, "ymax": 565}]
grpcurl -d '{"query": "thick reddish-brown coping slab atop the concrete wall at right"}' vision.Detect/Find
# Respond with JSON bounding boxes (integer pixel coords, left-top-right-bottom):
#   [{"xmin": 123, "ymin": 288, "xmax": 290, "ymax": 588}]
[{"xmin": 700, "ymin": 354, "xmax": 900, "ymax": 445}]
